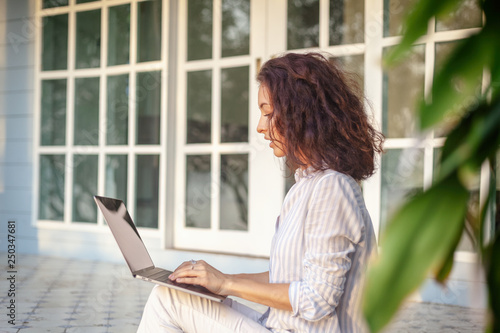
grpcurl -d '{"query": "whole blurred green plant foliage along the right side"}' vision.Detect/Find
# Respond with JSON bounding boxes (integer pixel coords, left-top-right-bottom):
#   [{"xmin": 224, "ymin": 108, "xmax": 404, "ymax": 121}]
[{"xmin": 364, "ymin": 0, "xmax": 500, "ymax": 332}]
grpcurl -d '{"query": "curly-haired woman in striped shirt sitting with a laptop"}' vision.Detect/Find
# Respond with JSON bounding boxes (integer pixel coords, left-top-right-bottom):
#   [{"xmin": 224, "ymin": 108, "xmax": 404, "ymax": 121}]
[{"xmin": 139, "ymin": 53, "xmax": 383, "ymax": 332}]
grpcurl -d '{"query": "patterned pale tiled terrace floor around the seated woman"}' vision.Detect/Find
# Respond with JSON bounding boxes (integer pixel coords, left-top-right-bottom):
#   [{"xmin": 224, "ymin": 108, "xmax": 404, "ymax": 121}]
[{"xmin": 0, "ymin": 253, "xmax": 485, "ymax": 333}]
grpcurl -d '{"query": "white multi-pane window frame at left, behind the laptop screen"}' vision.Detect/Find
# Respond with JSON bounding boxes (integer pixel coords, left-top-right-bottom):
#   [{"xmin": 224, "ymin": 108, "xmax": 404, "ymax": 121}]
[{"xmin": 32, "ymin": 0, "xmax": 169, "ymax": 237}]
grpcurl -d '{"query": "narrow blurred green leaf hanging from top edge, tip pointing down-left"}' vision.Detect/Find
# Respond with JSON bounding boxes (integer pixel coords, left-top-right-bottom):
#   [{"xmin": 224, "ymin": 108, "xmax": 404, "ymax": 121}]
[{"xmin": 386, "ymin": 0, "xmax": 462, "ymax": 65}]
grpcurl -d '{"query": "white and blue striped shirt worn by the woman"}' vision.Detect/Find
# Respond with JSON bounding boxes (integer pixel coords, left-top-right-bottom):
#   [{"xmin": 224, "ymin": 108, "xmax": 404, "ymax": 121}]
[{"xmin": 261, "ymin": 169, "xmax": 376, "ymax": 333}]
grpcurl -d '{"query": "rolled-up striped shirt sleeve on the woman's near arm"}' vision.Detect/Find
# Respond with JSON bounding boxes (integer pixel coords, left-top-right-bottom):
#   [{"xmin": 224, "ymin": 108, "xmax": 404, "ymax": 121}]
[{"xmin": 289, "ymin": 174, "xmax": 364, "ymax": 321}]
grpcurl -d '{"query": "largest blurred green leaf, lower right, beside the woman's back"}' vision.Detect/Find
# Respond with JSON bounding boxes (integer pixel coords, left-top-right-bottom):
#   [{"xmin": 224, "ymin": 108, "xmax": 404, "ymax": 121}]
[{"xmin": 364, "ymin": 174, "xmax": 469, "ymax": 332}]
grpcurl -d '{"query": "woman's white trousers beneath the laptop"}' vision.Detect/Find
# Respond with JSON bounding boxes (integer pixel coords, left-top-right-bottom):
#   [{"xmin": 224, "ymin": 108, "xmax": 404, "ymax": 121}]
[{"xmin": 137, "ymin": 285, "xmax": 270, "ymax": 333}]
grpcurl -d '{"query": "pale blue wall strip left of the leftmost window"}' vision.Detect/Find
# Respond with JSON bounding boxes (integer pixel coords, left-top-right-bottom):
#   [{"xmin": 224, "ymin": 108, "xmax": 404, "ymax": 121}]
[{"xmin": 0, "ymin": 0, "xmax": 37, "ymax": 252}]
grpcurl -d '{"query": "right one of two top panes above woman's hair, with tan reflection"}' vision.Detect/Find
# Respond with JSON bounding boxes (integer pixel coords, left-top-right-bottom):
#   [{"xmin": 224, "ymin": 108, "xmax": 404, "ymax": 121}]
[{"xmin": 330, "ymin": 0, "xmax": 365, "ymax": 45}]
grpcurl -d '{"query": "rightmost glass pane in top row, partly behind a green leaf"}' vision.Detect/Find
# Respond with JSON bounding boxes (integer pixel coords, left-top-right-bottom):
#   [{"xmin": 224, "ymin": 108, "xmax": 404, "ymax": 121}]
[{"xmin": 436, "ymin": 0, "xmax": 483, "ymax": 31}]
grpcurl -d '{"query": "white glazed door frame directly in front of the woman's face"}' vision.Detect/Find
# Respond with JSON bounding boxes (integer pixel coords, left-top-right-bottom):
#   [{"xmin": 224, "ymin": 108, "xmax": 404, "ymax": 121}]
[{"xmin": 175, "ymin": 0, "xmax": 284, "ymax": 256}]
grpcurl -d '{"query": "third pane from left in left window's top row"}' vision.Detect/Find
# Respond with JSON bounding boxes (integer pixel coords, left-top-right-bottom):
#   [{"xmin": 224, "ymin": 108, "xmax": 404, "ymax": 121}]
[{"xmin": 108, "ymin": 5, "xmax": 130, "ymax": 66}]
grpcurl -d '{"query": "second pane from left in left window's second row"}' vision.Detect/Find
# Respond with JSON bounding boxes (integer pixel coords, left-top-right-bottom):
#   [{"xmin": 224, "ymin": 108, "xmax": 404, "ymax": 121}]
[{"xmin": 73, "ymin": 77, "xmax": 99, "ymax": 146}]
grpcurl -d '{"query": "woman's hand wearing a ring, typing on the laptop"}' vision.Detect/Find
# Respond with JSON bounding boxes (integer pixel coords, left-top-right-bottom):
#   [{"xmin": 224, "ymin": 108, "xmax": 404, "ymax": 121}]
[{"xmin": 169, "ymin": 260, "xmax": 230, "ymax": 296}]
